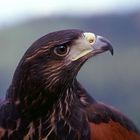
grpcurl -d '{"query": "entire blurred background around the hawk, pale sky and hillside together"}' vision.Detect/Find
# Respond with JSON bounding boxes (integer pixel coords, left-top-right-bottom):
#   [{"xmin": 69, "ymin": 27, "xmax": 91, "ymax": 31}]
[{"xmin": 0, "ymin": 0, "xmax": 140, "ymax": 128}]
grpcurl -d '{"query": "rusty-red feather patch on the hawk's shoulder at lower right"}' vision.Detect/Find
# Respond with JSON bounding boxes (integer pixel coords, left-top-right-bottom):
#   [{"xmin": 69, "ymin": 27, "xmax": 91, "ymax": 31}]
[{"xmin": 89, "ymin": 120, "xmax": 140, "ymax": 140}]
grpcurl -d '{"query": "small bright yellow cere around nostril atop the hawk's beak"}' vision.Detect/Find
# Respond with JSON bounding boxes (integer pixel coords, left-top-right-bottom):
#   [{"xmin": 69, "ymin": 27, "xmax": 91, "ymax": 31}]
[{"xmin": 84, "ymin": 32, "xmax": 96, "ymax": 44}]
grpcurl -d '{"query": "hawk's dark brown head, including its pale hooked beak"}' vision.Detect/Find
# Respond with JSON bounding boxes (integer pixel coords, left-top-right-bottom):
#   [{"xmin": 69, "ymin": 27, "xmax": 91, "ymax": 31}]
[{"xmin": 7, "ymin": 29, "xmax": 113, "ymax": 100}]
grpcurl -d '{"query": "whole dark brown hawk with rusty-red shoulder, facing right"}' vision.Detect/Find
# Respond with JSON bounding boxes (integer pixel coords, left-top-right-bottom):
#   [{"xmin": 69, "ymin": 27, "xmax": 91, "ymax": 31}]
[{"xmin": 0, "ymin": 29, "xmax": 140, "ymax": 140}]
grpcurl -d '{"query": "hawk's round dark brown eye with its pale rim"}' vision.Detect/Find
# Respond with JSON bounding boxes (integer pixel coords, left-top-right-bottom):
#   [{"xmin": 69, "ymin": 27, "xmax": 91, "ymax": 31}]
[{"xmin": 54, "ymin": 45, "xmax": 69, "ymax": 56}]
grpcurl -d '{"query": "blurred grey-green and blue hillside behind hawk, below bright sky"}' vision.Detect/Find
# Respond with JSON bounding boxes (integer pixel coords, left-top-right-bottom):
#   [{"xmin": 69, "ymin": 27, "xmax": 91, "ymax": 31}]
[{"xmin": 0, "ymin": 12, "xmax": 140, "ymax": 128}]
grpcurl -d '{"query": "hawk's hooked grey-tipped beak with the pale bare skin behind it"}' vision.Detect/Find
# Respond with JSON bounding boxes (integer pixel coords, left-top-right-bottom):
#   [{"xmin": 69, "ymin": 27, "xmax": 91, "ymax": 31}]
[{"xmin": 70, "ymin": 32, "xmax": 113, "ymax": 61}]
